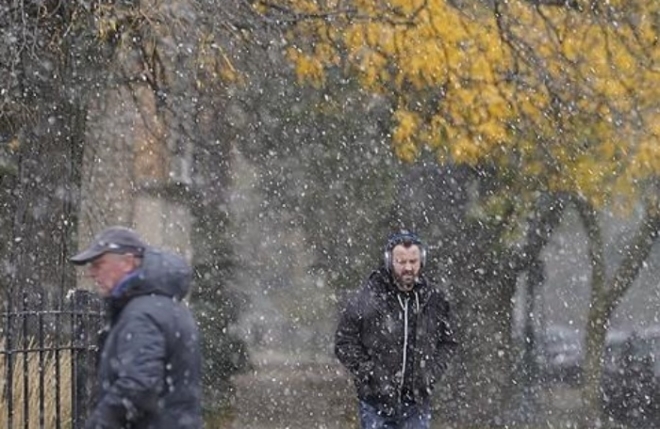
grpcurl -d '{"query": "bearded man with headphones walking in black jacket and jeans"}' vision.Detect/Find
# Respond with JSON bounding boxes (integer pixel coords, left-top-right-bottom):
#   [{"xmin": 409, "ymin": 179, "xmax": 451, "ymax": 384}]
[{"xmin": 335, "ymin": 231, "xmax": 456, "ymax": 429}]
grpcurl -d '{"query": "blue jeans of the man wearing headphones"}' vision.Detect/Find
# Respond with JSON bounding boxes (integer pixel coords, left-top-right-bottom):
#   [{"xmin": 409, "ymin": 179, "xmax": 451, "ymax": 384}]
[{"xmin": 358, "ymin": 401, "xmax": 431, "ymax": 429}]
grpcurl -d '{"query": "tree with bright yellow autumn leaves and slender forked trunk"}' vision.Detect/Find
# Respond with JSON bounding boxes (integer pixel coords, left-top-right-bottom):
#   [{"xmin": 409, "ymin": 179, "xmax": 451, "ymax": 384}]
[{"xmin": 258, "ymin": 0, "xmax": 660, "ymax": 422}]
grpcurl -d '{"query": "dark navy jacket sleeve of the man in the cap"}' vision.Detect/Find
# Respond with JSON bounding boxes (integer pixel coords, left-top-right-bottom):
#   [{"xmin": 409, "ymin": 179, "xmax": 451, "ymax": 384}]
[{"xmin": 85, "ymin": 312, "xmax": 166, "ymax": 429}]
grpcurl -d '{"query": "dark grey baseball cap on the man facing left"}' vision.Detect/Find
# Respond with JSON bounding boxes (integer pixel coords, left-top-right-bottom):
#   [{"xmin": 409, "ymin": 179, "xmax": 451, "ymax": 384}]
[{"xmin": 70, "ymin": 226, "xmax": 147, "ymax": 265}]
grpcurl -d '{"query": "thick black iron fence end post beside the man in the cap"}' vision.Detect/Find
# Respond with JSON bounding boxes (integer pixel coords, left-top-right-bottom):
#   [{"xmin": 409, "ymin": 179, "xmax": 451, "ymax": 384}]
[{"xmin": 72, "ymin": 289, "xmax": 101, "ymax": 429}]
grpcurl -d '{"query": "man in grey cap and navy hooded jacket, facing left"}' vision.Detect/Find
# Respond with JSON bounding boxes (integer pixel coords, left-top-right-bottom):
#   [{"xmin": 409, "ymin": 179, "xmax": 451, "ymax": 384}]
[{"xmin": 71, "ymin": 226, "xmax": 202, "ymax": 429}]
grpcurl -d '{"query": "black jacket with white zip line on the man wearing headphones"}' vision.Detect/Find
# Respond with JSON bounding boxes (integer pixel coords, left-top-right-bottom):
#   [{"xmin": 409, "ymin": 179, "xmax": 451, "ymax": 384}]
[{"xmin": 335, "ymin": 268, "xmax": 456, "ymax": 414}]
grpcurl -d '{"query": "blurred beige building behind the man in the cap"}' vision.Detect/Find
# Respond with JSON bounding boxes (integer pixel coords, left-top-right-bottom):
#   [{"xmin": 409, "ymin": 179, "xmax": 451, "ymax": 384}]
[{"xmin": 78, "ymin": 87, "xmax": 192, "ymax": 288}]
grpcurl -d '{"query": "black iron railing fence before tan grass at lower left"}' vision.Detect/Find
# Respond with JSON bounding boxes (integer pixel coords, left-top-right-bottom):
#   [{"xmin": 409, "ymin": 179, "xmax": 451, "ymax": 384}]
[{"xmin": 0, "ymin": 290, "xmax": 102, "ymax": 429}]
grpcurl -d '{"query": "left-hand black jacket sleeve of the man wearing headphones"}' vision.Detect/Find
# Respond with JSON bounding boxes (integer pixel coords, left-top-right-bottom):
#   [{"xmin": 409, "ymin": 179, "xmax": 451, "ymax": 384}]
[{"xmin": 335, "ymin": 293, "xmax": 373, "ymax": 383}]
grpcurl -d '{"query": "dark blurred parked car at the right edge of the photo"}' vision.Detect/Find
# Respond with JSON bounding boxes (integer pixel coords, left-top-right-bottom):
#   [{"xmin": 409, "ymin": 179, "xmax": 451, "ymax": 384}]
[{"xmin": 602, "ymin": 331, "xmax": 660, "ymax": 428}]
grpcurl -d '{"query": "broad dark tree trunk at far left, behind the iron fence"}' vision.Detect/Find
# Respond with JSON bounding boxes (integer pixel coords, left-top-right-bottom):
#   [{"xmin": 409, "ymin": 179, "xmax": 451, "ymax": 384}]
[{"xmin": 0, "ymin": 2, "xmax": 103, "ymax": 305}]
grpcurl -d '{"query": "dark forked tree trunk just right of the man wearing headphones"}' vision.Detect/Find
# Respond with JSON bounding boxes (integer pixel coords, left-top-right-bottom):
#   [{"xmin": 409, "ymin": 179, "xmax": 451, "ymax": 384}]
[{"xmin": 397, "ymin": 172, "xmax": 565, "ymax": 427}]
